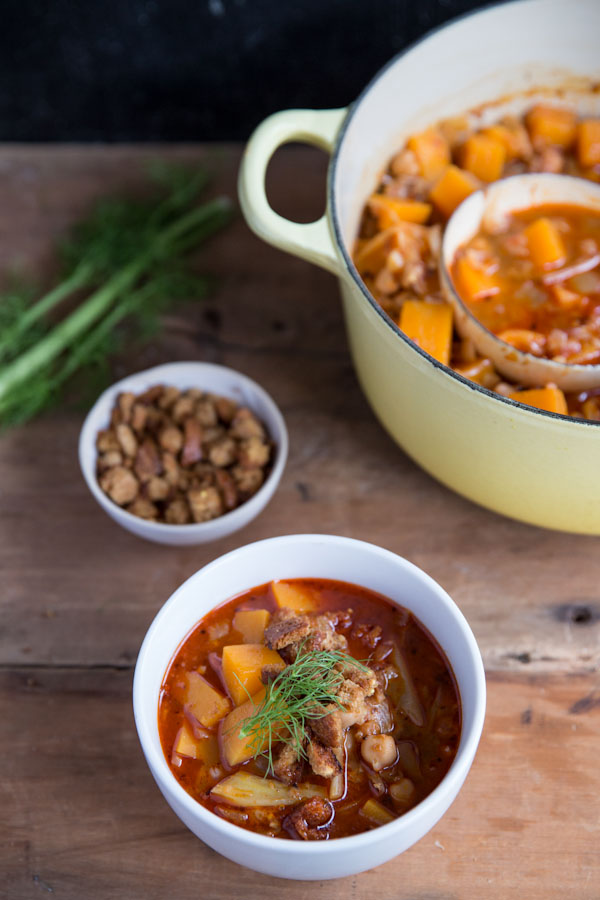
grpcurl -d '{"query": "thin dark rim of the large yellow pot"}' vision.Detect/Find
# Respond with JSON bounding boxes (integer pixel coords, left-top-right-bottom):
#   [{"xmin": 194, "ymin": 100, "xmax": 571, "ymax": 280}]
[{"xmin": 326, "ymin": 0, "xmax": 600, "ymax": 428}]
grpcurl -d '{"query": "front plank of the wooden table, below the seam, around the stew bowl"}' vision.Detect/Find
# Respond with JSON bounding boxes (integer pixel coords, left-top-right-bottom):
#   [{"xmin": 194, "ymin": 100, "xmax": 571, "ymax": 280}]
[{"xmin": 0, "ymin": 668, "xmax": 600, "ymax": 900}]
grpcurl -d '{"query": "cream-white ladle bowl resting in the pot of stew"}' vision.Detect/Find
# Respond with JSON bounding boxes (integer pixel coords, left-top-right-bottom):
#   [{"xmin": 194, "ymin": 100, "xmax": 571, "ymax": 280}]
[{"xmin": 440, "ymin": 173, "xmax": 600, "ymax": 391}]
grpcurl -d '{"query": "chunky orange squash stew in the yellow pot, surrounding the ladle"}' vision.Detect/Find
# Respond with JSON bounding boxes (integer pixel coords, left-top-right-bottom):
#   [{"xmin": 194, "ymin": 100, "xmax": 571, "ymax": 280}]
[{"xmin": 354, "ymin": 104, "xmax": 600, "ymax": 421}]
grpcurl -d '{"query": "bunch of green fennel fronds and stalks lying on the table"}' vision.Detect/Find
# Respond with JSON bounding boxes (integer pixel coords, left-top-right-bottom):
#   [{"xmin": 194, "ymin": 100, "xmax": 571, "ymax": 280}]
[{"xmin": 0, "ymin": 166, "xmax": 232, "ymax": 427}]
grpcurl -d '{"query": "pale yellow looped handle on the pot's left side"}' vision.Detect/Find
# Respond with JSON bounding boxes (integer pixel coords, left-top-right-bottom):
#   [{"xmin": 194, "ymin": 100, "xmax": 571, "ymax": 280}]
[{"xmin": 238, "ymin": 109, "xmax": 347, "ymax": 274}]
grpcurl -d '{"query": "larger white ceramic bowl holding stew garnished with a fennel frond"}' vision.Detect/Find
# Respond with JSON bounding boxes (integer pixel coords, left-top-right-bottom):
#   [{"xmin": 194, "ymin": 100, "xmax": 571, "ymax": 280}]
[{"xmin": 133, "ymin": 534, "xmax": 485, "ymax": 880}]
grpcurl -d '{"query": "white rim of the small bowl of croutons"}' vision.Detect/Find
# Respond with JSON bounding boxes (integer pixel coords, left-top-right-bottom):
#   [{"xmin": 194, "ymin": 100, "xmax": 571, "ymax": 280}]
[{"xmin": 78, "ymin": 360, "xmax": 289, "ymax": 536}]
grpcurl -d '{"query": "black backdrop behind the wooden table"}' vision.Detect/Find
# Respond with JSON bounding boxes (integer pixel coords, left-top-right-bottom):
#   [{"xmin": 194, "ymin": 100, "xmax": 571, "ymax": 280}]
[{"xmin": 0, "ymin": 0, "xmax": 492, "ymax": 141}]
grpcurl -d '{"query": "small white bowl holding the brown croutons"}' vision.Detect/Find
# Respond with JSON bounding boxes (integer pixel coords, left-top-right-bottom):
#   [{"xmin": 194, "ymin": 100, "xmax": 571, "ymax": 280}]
[{"xmin": 79, "ymin": 362, "xmax": 288, "ymax": 547}]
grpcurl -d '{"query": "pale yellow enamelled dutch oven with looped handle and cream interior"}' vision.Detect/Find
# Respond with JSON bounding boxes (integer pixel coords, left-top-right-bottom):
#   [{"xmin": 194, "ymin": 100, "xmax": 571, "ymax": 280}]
[{"xmin": 239, "ymin": 0, "xmax": 600, "ymax": 534}]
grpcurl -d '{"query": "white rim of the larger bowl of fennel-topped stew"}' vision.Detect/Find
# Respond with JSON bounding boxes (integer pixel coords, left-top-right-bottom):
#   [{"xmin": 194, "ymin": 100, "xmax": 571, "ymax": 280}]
[{"xmin": 133, "ymin": 533, "xmax": 486, "ymax": 857}]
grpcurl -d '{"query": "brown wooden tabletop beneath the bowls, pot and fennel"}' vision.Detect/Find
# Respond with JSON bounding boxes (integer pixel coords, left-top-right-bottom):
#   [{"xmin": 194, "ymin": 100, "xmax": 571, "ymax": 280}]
[{"xmin": 0, "ymin": 146, "xmax": 600, "ymax": 900}]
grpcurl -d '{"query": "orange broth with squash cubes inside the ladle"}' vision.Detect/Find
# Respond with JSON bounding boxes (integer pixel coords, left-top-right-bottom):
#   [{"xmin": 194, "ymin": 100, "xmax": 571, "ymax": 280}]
[{"xmin": 451, "ymin": 204, "xmax": 600, "ymax": 364}]
